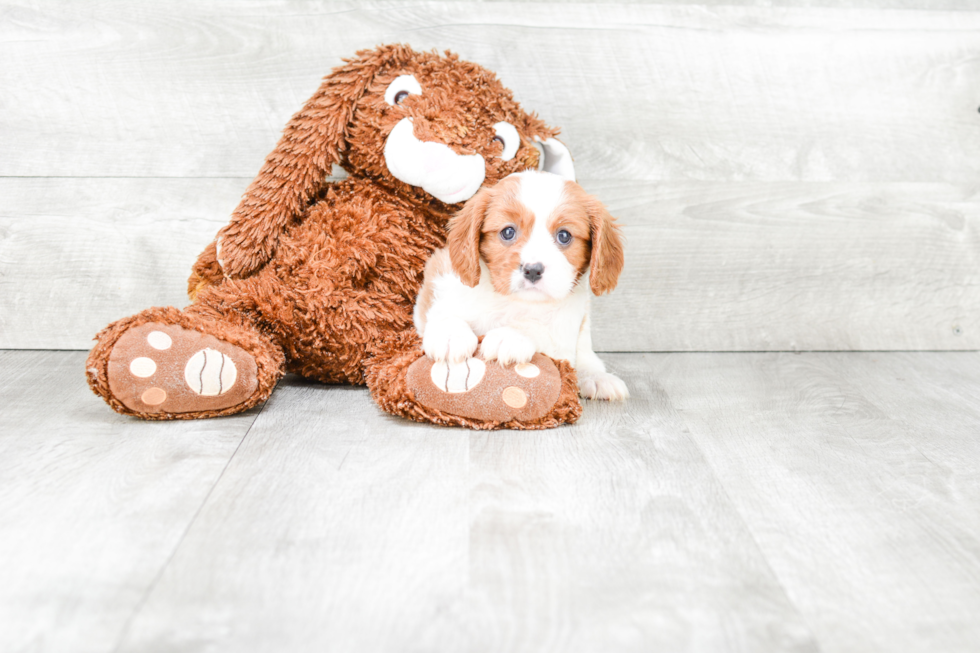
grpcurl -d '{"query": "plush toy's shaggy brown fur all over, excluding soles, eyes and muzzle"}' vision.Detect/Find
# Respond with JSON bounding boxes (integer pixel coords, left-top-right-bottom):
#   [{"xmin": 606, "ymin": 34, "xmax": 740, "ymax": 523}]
[{"xmin": 89, "ymin": 45, "xmax": 580, "ymax": 428}]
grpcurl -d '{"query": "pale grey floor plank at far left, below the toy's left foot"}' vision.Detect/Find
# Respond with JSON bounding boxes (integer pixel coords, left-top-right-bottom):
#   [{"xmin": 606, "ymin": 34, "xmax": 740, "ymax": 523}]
[{"xmin": 0, "ymin": 352, "xmax": 256, "ymax": 652}]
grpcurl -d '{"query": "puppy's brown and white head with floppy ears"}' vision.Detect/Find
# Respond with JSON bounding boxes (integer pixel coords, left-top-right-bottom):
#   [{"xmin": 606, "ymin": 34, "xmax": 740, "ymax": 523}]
[{"xmin": 446, "ymin": 172, "xmax": 623, "ymax": 301}]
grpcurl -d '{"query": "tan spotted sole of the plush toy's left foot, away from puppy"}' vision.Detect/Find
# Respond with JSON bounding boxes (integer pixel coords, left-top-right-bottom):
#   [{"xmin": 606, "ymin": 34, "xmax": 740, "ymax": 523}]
[{"xmin": 108, "ymin": 322, "xmax": 258, "ymax": 413}]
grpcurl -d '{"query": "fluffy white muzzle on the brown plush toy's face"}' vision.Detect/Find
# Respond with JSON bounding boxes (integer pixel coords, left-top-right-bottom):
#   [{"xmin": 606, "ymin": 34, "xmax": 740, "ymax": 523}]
[{"xmin": 385, "ymin": 118, "xmax": 486, "ymax": 204}]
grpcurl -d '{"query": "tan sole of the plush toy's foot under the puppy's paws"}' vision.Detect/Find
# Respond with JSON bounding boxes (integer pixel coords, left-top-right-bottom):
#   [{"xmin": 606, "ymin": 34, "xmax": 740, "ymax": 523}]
[{"xmin": 406, "ymin": 354, "xmax": 561, "ymax": 423}]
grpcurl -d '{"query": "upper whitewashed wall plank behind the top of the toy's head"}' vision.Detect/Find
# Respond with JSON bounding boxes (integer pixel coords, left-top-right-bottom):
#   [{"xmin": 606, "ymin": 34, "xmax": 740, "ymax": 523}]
[{"xmin": 0, "ymin": 0, "xmax": 980, "ymax": 183}]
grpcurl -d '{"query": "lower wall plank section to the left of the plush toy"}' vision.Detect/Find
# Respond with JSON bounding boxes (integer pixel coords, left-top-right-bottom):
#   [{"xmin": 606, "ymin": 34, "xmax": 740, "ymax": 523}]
[{"xmin": 0, "ymin": 179, "xmax": 249, "ymax": 349}]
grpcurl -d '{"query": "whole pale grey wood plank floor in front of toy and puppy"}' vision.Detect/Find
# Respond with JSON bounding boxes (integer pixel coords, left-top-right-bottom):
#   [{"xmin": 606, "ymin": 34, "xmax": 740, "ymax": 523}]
[{"xmin": 0, "ymin": 351, "xmax": 980, "ymax": 653}]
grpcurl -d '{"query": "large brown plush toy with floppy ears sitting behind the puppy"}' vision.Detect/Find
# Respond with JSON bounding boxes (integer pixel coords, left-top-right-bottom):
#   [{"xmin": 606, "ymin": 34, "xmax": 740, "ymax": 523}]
[{"xmin": 87, "ymin": 45, "xmax": 581, "ymax": 428}]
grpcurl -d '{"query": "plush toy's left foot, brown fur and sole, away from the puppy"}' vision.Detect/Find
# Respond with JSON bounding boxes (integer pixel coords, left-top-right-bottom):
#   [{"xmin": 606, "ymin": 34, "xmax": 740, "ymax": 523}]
[{"xmin": 88, "ymin": 309, "xmax": 282, "ymax": 419}]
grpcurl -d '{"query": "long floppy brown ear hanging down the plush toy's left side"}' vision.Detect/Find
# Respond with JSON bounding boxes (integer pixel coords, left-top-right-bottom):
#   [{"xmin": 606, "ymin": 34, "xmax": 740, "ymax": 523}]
[{"xmin": 216, "ymin": 45, "xmax": 417, "ymax": 277}]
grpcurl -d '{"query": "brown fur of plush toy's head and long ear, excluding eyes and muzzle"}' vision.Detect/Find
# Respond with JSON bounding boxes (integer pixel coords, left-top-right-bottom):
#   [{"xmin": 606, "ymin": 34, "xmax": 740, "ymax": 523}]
[{"xmin": 205, "ymin": 45, "xmax": 557, "ymax": 277}]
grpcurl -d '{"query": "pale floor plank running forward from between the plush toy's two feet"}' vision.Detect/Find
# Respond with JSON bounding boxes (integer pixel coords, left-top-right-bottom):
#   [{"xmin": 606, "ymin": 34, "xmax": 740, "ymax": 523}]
[{"xmin": 119, "ymin": 377, "xmax": 469, "ymax": 652}]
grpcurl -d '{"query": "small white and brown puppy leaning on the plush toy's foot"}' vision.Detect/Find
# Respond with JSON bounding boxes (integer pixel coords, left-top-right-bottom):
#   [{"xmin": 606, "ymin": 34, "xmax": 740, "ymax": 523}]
[{"xmin": 414, "ymin": 171, "xmax": 629, "ymax": 399}]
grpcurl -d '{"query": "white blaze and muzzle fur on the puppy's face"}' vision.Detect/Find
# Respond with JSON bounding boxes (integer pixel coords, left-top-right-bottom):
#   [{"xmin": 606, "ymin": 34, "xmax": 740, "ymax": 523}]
[{"xmin": 511, "ymin": 172, "xmax": 578, "ymax": 299}]
